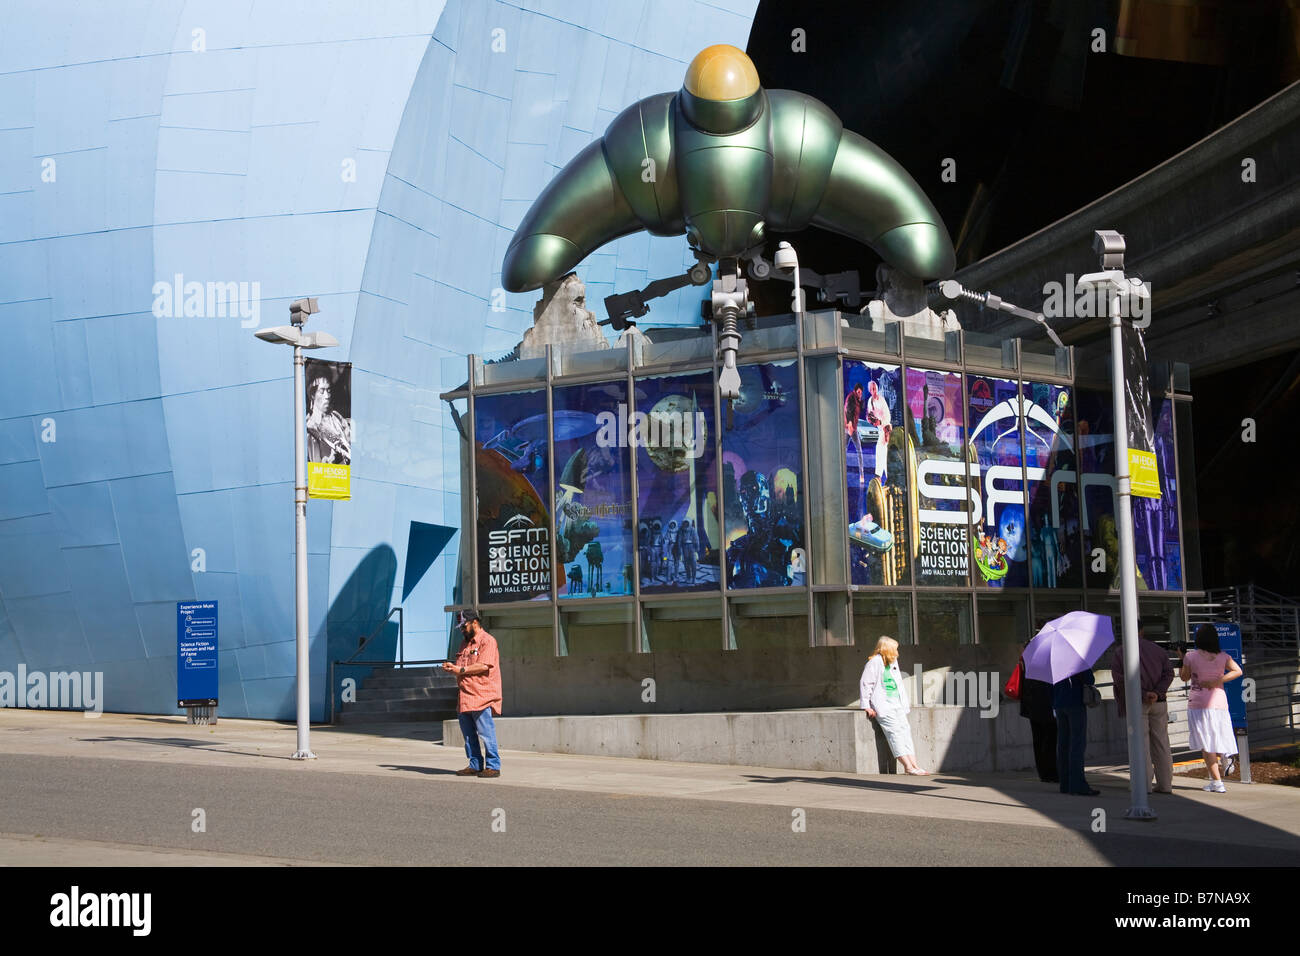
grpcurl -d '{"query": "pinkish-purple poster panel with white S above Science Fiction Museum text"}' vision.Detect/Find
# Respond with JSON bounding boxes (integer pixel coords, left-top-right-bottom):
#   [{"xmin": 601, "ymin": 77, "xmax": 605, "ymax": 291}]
[{"xmin": 906, "ymin": 368, "xmax": 974, "ymax": 587}]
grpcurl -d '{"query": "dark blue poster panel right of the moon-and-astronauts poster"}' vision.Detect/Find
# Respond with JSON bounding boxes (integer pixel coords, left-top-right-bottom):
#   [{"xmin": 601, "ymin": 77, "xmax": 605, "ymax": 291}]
[{"xmin": 723, "ymin": 362, "xmax": 807, "ymax": 588}]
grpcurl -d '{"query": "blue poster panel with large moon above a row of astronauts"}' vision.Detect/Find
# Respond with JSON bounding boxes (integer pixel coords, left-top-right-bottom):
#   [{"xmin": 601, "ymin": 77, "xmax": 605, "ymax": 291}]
[{"xmin": 628, "ymin": 372, "xmax": 720, "ymax": 594}]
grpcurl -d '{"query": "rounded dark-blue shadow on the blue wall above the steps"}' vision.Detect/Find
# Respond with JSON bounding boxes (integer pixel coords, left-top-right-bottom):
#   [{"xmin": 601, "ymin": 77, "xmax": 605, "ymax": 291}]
[{"xmin": 325, "ymin": 545, "xmax": 398, "ymax": 714}]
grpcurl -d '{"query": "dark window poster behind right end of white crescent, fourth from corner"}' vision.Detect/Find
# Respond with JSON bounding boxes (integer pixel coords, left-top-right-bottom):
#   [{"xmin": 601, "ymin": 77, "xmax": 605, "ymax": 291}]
[{"xmin": 1024, "ymin": 382, "xmax": 1083, "ymax": 588}]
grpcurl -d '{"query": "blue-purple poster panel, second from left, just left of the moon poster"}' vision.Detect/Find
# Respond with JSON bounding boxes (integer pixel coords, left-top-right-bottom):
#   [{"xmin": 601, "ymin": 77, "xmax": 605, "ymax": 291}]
[{"xmin": 551, "ymin": 382, "xmax": 636, "ymax": 597}]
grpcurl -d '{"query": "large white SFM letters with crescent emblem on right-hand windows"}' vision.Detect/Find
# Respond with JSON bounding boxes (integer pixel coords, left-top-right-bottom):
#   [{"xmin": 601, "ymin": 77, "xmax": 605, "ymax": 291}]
[{"xmin": 917, "ymin": 395, "xmax": 1115, "ymax": 529}]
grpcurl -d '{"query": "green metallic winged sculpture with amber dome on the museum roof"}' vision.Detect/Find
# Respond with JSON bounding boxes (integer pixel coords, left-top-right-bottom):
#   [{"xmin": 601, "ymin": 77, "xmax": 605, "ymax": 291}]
[{"xmin": 502, "ymin": 46, "xmax": 956, "ymax": 397}]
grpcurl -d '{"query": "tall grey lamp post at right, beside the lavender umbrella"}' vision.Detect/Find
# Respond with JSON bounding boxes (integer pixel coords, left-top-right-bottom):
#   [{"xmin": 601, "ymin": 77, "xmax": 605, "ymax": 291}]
[{"xmin": 1076, "ymin": 229, "xmax": 1156, "ymax": 819}]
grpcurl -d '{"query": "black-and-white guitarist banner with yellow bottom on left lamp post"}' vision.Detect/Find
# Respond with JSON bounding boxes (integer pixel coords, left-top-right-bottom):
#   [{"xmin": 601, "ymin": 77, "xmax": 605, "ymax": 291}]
[{"xmin": 303, "ymin": 359, "xmax": 352, "ymax": 501}]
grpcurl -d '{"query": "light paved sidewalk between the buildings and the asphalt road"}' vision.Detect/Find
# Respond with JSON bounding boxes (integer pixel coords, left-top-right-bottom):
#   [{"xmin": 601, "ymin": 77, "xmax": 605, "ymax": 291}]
[{"xmin": 0, "ymin": 709, "xmax": 1300, "ymax": 862}]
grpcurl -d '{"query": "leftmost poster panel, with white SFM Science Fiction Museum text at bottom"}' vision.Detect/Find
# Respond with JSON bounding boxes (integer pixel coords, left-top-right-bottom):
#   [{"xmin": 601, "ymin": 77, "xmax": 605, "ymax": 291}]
[{"xmin": 475, "ymin": 392, "xmax": 551, "ymax": 604}]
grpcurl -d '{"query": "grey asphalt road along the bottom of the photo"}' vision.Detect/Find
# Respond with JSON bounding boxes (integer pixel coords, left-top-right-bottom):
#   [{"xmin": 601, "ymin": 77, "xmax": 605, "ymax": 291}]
[{"xmin": 0, "ymin": 754, "xmax": 1300, "ymax": 866}]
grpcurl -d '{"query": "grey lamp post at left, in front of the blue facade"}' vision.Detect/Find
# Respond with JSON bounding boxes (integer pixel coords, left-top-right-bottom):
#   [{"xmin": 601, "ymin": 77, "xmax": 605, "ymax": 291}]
[{"xmin": 254, "ymin": 299, "xmax": 338, "ymax": 760}]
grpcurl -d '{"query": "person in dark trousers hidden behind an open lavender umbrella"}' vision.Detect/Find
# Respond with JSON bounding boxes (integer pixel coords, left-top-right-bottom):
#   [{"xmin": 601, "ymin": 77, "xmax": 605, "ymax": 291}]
[{"xmin": 1024, "ymin": 611, "xmax": 1115, "ymax": 796}]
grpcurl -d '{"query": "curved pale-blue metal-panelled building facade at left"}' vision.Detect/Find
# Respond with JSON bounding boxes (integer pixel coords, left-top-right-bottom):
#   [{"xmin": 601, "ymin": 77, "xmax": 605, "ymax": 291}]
[{"xmin": 0, "ymin": 0, "xmax": 757, "ymax": 719}]
